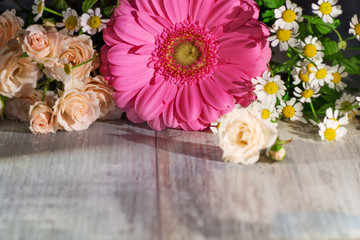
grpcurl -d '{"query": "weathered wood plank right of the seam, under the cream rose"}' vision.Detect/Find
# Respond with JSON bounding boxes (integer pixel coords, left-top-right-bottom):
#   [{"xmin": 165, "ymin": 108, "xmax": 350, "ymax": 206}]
[{"xmin": 157, "ymin": 120, "xmax": 360, "ymax": 240}]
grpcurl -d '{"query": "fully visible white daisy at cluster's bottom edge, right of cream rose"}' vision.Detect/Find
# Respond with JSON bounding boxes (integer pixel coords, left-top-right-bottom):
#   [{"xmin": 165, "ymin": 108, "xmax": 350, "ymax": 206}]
[{"xmin": 276, "ymin": 97, "xmax": 305, "ymax": 122}]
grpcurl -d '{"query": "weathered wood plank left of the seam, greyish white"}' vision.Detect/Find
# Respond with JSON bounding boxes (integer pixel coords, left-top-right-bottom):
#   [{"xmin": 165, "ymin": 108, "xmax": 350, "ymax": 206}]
[{"xmin": 0, "ymin": 121, "xmax": 160, "ymax": 240}]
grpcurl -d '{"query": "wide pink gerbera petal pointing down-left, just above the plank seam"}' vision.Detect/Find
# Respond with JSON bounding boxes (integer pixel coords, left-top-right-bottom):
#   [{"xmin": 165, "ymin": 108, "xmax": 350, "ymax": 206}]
[{"xmin": 135, "ymin": 82, "xmax": 168, "ymax": 121}]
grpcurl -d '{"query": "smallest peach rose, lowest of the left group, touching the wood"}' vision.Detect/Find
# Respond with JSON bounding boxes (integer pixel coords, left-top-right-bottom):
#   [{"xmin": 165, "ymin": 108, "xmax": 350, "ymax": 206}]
[{"xmin": 29, "ymin": 101, "xmax": 57, "ymax": 134}]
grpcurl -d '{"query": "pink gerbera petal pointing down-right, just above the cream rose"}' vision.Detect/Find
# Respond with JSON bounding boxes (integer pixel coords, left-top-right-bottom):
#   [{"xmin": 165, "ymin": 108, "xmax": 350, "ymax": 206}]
[{"xmin": 199, "ymin": 78, "xmax": 234, "ymax": 110}]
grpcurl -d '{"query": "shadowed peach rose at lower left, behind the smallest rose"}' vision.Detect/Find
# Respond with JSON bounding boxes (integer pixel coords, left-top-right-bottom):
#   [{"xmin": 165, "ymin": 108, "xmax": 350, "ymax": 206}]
[{"xmin": 4, "ymin": 89, "xmax": 56, "ymax": 122}]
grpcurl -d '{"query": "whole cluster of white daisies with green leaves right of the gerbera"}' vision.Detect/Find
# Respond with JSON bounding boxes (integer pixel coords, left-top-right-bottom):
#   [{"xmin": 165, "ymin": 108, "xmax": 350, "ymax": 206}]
[{"xmin": 252, "ymin": 0, "xmax": 360, "ymax": 141}]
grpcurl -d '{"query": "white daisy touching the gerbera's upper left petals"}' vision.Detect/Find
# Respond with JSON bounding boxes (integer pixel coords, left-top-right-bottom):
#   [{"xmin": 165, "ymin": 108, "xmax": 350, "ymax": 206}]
[{"xmin": 80, "ymin": 8, "xmax": 110, "ymax": 35}]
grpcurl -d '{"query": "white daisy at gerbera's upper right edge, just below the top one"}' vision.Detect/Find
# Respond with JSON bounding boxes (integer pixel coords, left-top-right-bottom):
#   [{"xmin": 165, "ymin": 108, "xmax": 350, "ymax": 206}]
[{"xmin": 268, "ymin": 24, "xmax": 299, "ymax": 51}]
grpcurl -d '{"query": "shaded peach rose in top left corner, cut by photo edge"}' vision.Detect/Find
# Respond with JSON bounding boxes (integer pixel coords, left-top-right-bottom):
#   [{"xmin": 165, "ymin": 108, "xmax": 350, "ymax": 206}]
[{"xmin": 0, "ymin": 10, "xmax": 24, "ymax": 48}]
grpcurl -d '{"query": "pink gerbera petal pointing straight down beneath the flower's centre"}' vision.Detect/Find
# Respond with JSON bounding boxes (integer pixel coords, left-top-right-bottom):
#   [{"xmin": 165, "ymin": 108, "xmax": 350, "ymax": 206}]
[{"xmin": 176, "ymin": 84, "xmax": 202, "ymax": 122}]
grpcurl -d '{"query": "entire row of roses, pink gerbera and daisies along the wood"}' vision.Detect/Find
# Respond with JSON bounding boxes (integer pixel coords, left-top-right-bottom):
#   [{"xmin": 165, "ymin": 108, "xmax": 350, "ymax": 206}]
[{"xmin": 0, "ymin": 0, "xmax": 360, "ymax": 164}]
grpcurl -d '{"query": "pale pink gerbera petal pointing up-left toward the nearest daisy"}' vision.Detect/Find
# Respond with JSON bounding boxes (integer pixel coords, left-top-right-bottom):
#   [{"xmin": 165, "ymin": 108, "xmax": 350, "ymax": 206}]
[{"xmin": 114, "ymin": 15, "xmax": 155, "ymax": 45}]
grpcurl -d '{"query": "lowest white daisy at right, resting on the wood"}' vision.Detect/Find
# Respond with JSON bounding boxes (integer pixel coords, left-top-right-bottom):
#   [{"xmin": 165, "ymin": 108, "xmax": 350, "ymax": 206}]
[{"xmin": 319, "ymin": 120, "xmax": 346, "ymax": 142}]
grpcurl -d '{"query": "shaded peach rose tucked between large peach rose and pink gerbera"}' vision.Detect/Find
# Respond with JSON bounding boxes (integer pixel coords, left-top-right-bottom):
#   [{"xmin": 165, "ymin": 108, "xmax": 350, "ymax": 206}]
[{"xmin": 83, "ymin": 75, "xmax": 115, "ymax": 118}]
